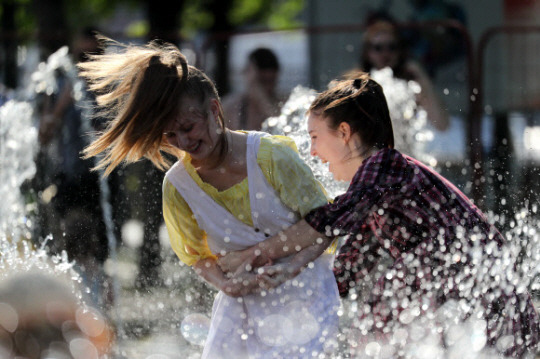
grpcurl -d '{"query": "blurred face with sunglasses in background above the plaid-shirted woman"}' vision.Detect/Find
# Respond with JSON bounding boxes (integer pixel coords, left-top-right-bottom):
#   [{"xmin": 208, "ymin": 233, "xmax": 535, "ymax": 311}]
[{"xmin": 366, "ymin": 32, "xmax": 399, "ymax": 70}]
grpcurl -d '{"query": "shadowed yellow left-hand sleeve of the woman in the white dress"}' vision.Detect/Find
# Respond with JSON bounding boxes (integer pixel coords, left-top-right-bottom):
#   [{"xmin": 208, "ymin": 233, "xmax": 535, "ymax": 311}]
[{"xmin": 163, "ymin": 179, "xmax": 216, "ymax": 266}]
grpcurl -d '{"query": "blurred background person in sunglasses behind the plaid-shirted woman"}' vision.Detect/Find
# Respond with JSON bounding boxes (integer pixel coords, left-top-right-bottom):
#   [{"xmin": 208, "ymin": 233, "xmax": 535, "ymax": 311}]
[{"xmin": 360, "ymin": 19, "xmax": 449, "ymax": 131}]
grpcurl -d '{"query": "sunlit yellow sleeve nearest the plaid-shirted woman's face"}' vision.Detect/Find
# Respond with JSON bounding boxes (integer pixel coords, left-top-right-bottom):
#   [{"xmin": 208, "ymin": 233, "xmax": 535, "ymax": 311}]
[{"xmin": 257, "ymin": 136, "xmax": 328, "ymax": 217}]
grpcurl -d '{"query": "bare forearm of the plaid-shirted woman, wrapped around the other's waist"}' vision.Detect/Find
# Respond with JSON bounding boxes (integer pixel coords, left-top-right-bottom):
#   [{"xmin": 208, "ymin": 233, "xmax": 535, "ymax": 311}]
[{"xmin": 218, "ymin": 219, "xmax": 331, "ymax": 272}]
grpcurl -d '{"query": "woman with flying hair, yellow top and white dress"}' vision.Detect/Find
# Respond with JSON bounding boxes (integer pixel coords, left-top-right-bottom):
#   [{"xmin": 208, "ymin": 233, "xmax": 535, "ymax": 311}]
[{"xmin": 80, "ymin": 39, "xmax": 339, "ymax": 358}]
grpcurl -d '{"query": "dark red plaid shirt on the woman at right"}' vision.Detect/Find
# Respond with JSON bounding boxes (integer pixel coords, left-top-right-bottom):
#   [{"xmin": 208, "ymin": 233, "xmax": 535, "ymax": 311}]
[{"xmin": 305, "ymin": 149, "xmax": 539, "ymax": 354}]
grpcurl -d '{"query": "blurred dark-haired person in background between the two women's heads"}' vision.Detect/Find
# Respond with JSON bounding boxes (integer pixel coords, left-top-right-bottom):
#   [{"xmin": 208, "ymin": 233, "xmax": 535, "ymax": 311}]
[{"xmin": 223, "ymin": 48, "xmax": 283, "ymax": 131}]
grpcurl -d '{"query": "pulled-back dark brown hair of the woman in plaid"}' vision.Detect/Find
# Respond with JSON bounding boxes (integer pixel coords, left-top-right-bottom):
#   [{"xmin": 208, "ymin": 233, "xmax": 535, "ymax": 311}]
[{"xmin": 308, "ymin": 72, "xmax": 394, "ymax": 149}]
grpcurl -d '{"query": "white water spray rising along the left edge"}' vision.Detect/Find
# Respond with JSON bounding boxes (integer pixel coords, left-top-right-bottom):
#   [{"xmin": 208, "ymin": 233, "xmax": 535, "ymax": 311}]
[{"xmin": 0, "ymin": 47, "xmax": 112, "ymax": 310}]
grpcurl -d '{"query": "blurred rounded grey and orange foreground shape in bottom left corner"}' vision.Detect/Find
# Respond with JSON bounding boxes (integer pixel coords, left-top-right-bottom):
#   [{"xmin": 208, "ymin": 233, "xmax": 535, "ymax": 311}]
[{"xmin": 0, "ymin": 269, "xmax": 113, "ymax": 359}]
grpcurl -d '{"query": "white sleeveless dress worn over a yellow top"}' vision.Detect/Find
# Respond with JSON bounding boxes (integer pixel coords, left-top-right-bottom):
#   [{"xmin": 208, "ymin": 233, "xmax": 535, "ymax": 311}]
[{"xmin": 166, "ymin": 132, "xmax": 339, "ymax": 359}]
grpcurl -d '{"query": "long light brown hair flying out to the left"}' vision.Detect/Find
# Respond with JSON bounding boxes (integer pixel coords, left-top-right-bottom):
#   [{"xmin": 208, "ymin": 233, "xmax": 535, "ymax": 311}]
[{"xmin": 77, "ymin": 37, "xmax": 227, "ymax": 175}]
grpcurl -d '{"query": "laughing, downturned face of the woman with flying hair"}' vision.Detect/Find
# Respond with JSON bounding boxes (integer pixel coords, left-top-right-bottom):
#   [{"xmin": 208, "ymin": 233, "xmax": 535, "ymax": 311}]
[{"xmin": 163, "ymin": 97, "xmax": 223, "ymax": 162}]
